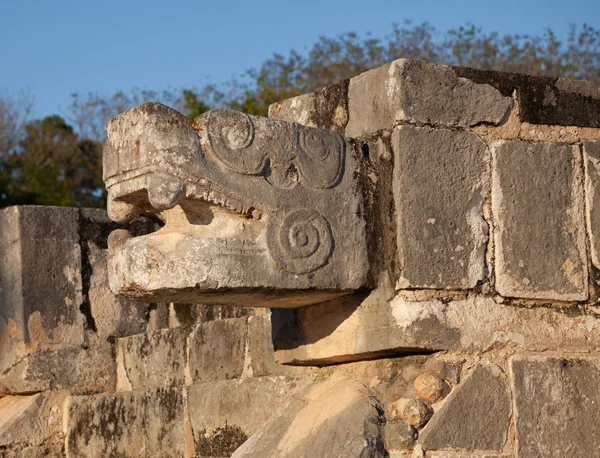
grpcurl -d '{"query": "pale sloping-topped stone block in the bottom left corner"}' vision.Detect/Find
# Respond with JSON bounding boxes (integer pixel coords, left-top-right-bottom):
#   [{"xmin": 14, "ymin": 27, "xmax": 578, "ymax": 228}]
[{"xmin": 0, "ymin": 392, "xmax": 68, "ymax": 450}]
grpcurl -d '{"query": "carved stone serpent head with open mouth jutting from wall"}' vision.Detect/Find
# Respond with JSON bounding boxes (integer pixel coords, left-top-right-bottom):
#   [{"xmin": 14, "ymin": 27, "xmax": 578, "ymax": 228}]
[{"xmin": 104, "ymin": 103, "xmax": 368, "ymax": 307}]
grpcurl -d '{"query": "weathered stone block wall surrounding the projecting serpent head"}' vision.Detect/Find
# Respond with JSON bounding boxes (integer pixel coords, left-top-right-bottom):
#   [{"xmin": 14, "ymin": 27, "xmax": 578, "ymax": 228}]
[{"xmin": 0, "ymin": 60, "xmax": 600, "ymax": 458}]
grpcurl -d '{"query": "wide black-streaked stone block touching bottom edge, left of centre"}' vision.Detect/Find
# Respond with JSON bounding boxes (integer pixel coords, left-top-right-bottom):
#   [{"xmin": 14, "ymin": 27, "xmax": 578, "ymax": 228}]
[{"xmin": 66, "ymin": 388, "xmax": 185, "ymax": 457}]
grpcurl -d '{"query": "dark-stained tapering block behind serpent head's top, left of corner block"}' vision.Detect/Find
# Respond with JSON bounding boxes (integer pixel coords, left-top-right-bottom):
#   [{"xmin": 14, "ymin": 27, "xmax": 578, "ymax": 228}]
[{"xmin": 269, "ymin": 80, "xmax": 349, "ymax": 133}]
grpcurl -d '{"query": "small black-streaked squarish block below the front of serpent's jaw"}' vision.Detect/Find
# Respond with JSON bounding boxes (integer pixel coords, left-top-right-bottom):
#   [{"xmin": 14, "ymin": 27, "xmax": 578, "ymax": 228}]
[{"xmin": 117, "ymin": 328, "xmax": 188, "ymax": 391}]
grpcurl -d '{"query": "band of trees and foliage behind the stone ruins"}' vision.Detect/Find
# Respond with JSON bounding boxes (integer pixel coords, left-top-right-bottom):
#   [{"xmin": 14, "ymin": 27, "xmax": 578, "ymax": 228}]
[{"xmin": 0, "ymin": 22, "xmax": 600, "ymax": 206}]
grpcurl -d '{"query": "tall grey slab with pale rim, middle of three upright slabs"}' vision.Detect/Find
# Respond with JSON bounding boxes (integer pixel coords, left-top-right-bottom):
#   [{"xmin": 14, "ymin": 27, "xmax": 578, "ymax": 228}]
[{"xmin": 492, "ymin": 141, "xmax": 588, "ymax": 301}]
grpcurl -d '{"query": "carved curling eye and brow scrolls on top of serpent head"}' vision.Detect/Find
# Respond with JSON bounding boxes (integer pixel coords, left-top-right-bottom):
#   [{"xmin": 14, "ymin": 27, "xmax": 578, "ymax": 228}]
[{"xmin": 206, "ymin": 110, "xmax": 345, "ymax": 189}]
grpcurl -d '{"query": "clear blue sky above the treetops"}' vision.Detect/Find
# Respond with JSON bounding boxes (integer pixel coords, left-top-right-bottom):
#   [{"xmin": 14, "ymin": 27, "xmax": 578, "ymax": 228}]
[{"xmin": 0, "ymin": 0, "xmax": 600, "ymax": 116}]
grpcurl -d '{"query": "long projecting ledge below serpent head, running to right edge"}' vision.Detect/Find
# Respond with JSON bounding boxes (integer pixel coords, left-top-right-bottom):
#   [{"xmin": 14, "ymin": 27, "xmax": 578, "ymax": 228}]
[{"xmin": 274, "ymin": 295, "xmax": 600, "ymax": 365}]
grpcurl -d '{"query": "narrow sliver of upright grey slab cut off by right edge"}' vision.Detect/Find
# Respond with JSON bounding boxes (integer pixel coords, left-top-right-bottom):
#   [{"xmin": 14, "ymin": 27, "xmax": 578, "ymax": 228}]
[{"xmin": 583, "ymin": 141, "xmax": 600, "ymax": 268}]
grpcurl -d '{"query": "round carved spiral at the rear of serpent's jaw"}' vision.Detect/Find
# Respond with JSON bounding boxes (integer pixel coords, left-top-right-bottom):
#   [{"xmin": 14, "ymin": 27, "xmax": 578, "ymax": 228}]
[{"xmin": 267, "ymin": 208, "xmax": 333, "ymax": 274}]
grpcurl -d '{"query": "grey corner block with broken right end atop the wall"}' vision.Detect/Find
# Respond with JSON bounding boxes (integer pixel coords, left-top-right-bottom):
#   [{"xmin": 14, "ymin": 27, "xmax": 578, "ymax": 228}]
[{"xmin": 345, "ymin": 59, "xmax": 512, "ymax": 137}]
